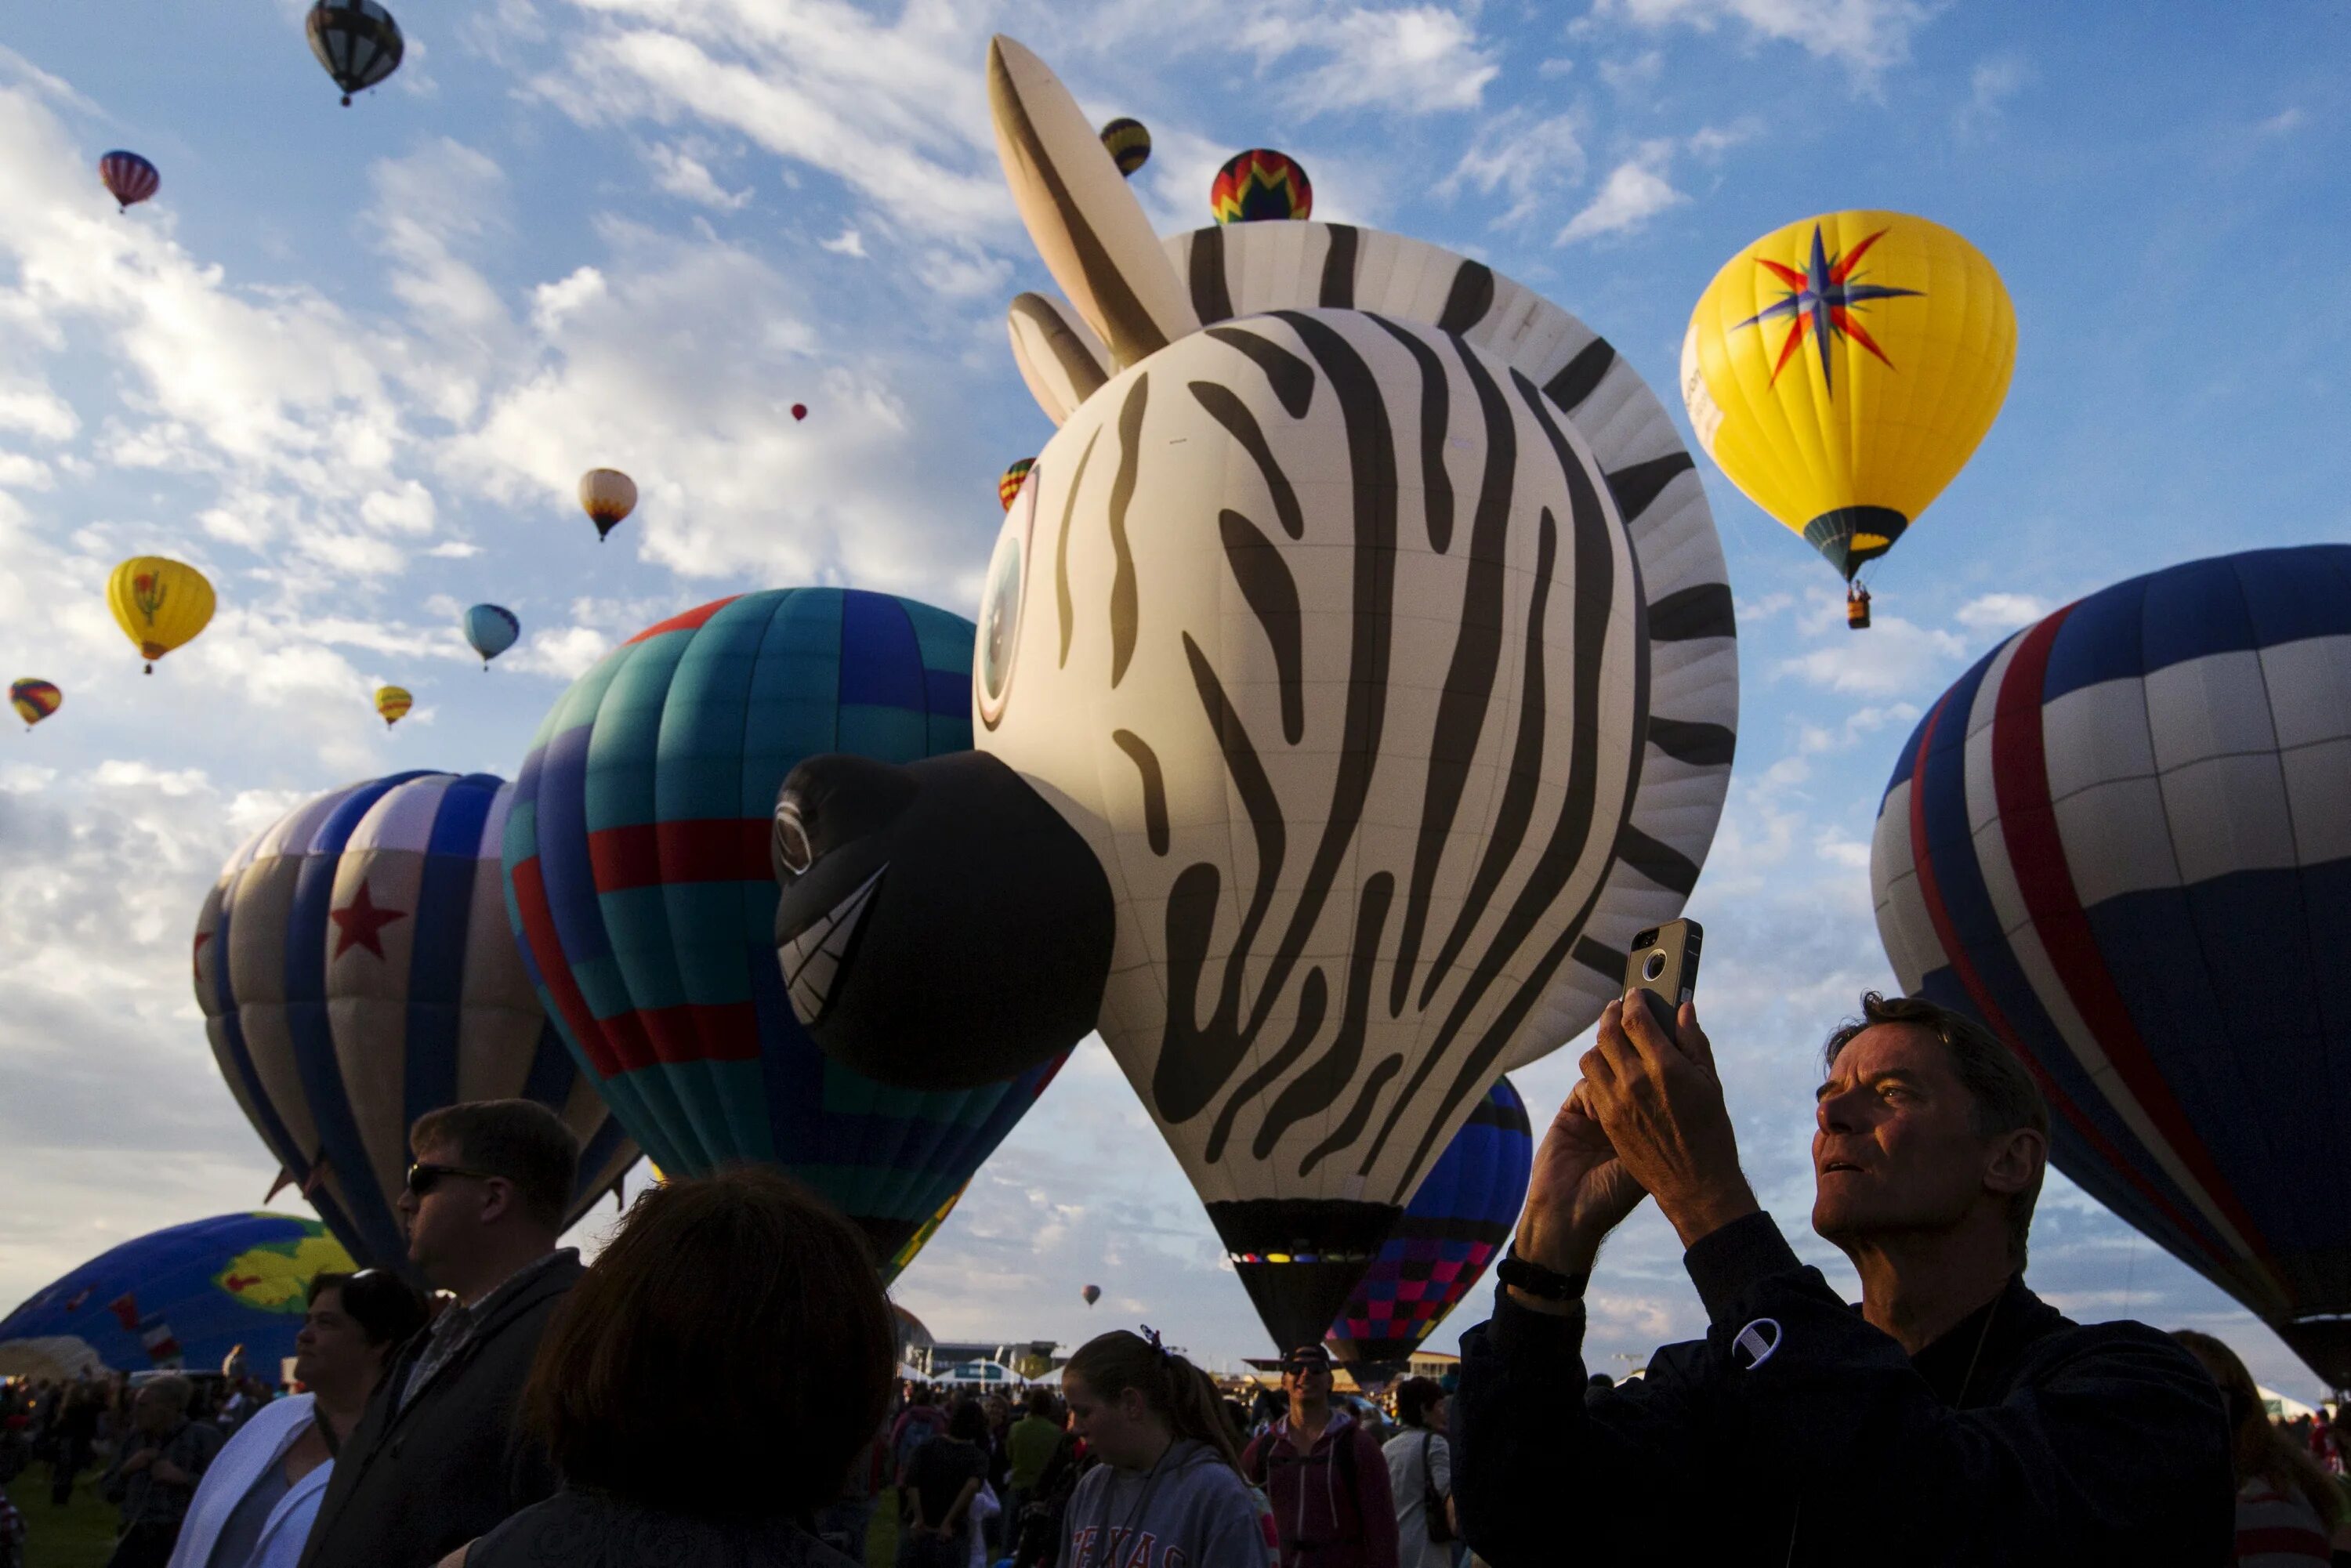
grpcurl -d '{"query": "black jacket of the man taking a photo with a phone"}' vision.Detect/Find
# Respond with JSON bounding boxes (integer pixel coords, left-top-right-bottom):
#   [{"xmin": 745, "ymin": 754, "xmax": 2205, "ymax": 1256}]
[{"xmin": 1453, "ymin": 1213, "xmax": 2236, "ymax": 1568}]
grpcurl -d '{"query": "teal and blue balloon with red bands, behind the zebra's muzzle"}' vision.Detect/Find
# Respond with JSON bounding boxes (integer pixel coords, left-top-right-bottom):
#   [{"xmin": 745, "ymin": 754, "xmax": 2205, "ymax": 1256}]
[{"xmin": 505, "ymin": 588, "xmax": 1060, "ymax": 1274}]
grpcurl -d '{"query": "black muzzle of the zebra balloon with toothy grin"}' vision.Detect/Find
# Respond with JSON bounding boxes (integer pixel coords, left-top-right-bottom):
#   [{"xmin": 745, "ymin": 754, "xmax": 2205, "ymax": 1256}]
[{"xmin": 773, "ymin": 752, "xmax": 1117, "ymax": 1088}]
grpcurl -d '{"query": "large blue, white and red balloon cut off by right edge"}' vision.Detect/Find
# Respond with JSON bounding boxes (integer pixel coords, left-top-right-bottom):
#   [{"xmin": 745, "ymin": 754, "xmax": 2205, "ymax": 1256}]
[{"xmin": 1869, "ymin": 545, "xmax": 2351, "ymax": 1387}]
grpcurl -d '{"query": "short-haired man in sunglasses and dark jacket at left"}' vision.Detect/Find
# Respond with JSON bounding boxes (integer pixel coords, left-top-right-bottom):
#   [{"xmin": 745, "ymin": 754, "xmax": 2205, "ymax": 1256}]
[{"xmin": 301, "ymin": 1100, "xmax": 583, "ymax": 1568}]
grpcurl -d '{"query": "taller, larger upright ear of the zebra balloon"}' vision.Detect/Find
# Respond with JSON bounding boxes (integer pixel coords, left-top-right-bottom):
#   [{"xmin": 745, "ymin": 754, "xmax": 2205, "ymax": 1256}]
[{"xmin": 987, "ymin": 35, "xmax": 1199, "ymax": 369}]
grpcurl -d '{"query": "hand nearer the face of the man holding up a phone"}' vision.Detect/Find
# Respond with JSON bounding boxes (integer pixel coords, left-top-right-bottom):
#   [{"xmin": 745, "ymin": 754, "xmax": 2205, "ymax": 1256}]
[{"xmin": 1578, "ymin": 999, "xmax": 1759, "ymax": 1248}]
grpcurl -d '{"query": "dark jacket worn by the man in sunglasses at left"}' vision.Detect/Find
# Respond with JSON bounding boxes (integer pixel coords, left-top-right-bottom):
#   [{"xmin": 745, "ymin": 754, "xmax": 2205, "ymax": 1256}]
[{"xmin": 301, "ymin": 1253, "xmax": 585, "ymax": 1568}]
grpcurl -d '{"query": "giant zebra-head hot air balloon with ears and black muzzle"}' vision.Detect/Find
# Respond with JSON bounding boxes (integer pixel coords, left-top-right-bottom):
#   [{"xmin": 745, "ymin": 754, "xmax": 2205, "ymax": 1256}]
[{"xmin": 776, "ymin": 40, "xmax": 1737, "ymax": 1347}]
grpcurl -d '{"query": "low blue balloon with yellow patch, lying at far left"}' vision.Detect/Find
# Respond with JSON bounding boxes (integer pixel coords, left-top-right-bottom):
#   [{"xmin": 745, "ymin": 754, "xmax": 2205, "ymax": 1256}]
[{"xmin": 0, "ymin": 1213, "xmax": 355, "ymax": 1380}]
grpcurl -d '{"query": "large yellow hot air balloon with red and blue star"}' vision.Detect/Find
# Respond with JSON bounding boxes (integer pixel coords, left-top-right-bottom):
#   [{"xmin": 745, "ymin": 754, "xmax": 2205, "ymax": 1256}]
[{"xmin": 1681, "ymin": 212, "xmax": 2017, "ymax": 628}]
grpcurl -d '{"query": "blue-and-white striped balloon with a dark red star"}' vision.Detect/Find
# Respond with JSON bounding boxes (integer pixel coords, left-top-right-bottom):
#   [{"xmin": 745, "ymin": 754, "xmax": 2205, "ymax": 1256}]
[{"xmin": 195, "ymin": 771, "xmax": 637, "ymax": 1267}]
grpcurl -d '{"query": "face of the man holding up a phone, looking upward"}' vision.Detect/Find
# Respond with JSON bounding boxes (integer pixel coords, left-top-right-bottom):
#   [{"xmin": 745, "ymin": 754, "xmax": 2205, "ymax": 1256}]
[{"xmin": 1813, "ymin": 1023, "xmax": 1991, "ymax": 1251}]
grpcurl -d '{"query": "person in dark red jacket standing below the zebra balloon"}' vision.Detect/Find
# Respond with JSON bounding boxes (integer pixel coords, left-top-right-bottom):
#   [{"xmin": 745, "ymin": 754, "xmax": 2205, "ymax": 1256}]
[{"xmin": 1241, "ymin": 1345, "xmax": 1396, "ymax": 1568}]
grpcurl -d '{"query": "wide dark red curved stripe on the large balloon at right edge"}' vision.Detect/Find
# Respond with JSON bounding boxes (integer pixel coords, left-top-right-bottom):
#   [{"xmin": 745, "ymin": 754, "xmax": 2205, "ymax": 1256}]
[{"xmin": 1991, "ymin": 607, "xmax": 2271, "ymax": 1262}]
